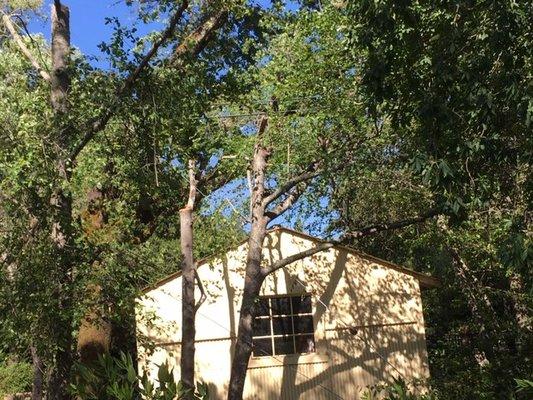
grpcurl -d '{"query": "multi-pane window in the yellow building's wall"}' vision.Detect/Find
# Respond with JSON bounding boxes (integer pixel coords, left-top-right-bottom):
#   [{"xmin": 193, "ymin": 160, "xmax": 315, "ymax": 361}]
[{"xmin": 253, "ymin": 295, "xmax": 315, "ymax": 357}]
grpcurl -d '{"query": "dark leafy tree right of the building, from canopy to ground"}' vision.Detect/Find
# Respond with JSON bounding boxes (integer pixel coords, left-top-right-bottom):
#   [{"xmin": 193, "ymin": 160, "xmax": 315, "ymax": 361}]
[{"xmin": 344, "ymin": 1, "xmax": 533, "ymax": 398}]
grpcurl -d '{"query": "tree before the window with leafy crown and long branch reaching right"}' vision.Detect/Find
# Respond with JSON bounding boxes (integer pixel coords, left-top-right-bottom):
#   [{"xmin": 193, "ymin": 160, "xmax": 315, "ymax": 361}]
[{"xmin": 222, "ymin": 4, "xmax": 450, "ymax": 399}]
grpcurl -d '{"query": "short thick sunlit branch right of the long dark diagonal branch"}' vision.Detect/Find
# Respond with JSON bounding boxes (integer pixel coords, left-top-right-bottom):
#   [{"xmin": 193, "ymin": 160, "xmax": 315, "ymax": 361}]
[{"xmin": 171, "ymin": 10, "xmax": 228, "ymax": 66}]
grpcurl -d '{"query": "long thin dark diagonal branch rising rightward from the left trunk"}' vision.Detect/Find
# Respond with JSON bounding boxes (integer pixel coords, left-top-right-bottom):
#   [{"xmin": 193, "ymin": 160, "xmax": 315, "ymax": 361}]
[{"xmin": 69, "ymin": 0, "xmax": 189, "ymax": 163}]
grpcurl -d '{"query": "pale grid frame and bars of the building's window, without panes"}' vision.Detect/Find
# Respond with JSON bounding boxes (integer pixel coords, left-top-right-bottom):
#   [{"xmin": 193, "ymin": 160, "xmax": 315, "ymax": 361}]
[{"xmin": 252, "ymin": 293, "xmax": 317, "ymax": 359}]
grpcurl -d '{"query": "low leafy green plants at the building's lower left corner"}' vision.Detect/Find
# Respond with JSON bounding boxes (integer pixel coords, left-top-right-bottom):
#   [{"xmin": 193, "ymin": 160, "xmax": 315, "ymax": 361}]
[{"xmin": 71, "ymin": 353, "xmax": 208, "ymax": 400}]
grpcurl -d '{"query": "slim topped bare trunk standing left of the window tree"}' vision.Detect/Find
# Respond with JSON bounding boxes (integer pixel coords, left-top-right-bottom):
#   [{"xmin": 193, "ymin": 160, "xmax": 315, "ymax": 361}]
[{"xmin": 180, "ymin": 160, "xmax": 196, "ymax": 399}]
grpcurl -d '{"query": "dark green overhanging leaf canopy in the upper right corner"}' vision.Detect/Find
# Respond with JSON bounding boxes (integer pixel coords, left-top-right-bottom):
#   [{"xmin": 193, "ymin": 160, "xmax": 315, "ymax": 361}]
[{"xmin": 348, "ymin": 1, "xmax": 533, "ymax": 212}]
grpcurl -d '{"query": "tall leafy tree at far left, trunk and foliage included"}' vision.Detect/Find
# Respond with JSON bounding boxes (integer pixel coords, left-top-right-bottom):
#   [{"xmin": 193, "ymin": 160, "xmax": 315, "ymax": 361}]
[{"xmin": 2, "ymin": 1, "xmax": 266, "ymax": 398}]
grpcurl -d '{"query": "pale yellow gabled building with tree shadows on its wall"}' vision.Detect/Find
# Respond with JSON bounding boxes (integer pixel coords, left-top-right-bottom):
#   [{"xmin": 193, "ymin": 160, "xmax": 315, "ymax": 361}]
[{"xmin": 137, "ymin": 228, "xmax": 437, "ymax": 400}]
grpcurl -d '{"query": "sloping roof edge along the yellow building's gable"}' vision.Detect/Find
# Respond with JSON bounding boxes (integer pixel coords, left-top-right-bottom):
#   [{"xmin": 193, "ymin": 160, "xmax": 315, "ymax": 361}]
[{"xmin": 142, "ymin": 226, "xmax": 440, "ymax": 293}]
